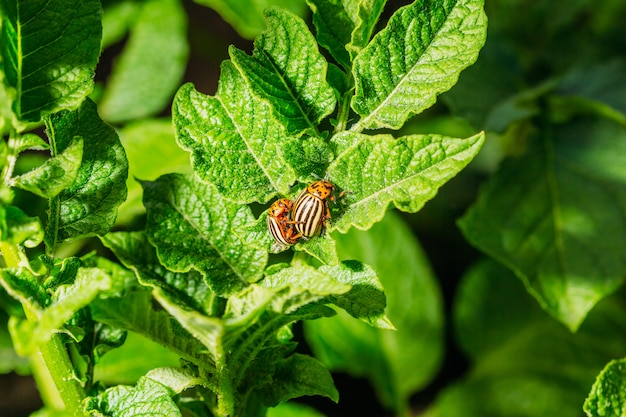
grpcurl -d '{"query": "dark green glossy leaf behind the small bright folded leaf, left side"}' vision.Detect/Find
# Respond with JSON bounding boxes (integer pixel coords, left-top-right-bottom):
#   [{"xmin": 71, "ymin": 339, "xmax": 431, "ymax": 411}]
[{"xmin": 45, "ymin": 99, "xmax": 128, "ymax": 248}]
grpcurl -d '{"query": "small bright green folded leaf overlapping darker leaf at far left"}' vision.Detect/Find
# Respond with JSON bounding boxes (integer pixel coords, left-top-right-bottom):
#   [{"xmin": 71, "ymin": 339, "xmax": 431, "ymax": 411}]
[{"xmin": 15, "ymin": 137, "xmax": 83, "ymax": 198}]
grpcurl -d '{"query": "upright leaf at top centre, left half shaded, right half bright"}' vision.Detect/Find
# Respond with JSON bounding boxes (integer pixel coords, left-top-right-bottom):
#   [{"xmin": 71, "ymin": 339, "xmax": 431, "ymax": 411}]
[{"xmin": 229, "ymin": 8, "xmax": 336, "ymax": 136}]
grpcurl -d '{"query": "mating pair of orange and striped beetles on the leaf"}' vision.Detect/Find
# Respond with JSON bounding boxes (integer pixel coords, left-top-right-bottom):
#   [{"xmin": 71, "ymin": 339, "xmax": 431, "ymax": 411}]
[{"xmin": 267, "ymin": 179, "xmax": 345, "ymax": 246}]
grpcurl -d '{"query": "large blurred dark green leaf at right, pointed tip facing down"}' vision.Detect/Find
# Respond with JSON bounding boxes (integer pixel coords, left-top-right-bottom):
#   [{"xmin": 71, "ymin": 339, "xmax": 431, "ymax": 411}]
[{"xmin": 459, "ymin": 120, "xmax": 626, "ymax": 331}]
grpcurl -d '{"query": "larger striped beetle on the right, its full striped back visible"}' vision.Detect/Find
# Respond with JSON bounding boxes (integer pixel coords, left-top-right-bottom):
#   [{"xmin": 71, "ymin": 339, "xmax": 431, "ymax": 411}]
[{"xmin": 292, "ymin": 179, "xmax": 345, "ymax": 237}]
